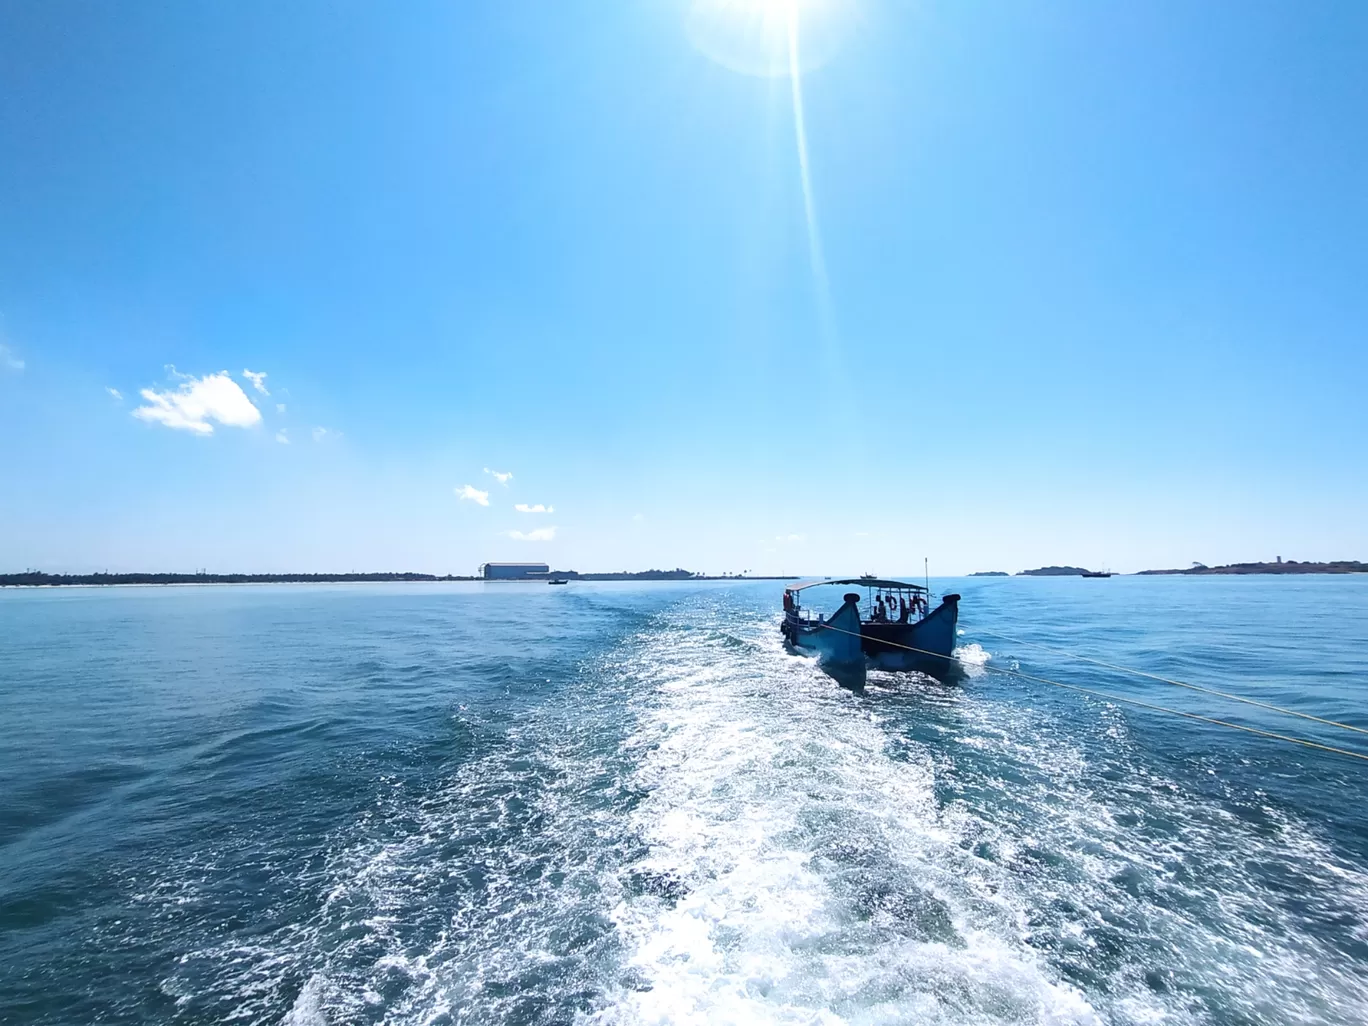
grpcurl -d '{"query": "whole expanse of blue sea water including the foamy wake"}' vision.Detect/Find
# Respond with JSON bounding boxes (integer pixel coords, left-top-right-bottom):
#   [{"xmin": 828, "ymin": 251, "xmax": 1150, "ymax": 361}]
[{"xmin": 0, "ymin": 577, "xmax": 1368, "ymax": 1026}]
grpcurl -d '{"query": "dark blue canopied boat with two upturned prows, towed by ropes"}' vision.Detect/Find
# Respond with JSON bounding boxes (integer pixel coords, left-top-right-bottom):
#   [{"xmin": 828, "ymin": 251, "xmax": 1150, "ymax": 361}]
[{"xmin": 780, "ymin": 576, "xmax": 959, "ymax": 676}]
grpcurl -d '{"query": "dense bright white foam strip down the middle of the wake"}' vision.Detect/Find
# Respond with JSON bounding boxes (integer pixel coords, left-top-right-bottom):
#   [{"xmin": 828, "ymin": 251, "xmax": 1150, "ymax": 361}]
[{"xmin": 601, "ymin": 607, "xmax": 1096, "ymax": 1023}]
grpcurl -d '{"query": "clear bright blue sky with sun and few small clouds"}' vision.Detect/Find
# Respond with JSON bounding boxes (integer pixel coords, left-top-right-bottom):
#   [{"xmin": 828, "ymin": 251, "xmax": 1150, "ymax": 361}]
[{"xmin": 0, "ymin": 0, "xmax": 1368, "ymax": 575}]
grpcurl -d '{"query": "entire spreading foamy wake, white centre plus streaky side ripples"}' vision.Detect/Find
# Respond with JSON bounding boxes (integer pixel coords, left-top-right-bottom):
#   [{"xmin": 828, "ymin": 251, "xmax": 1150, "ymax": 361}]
[{"xmin": 138, "ymin": 592, "xmax": 1368, "ymax": 1026}]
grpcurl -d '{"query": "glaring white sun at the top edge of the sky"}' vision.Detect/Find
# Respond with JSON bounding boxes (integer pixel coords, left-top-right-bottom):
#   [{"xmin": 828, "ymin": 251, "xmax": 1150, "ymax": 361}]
[{"xmin": 688, "ymin": 0, "xmax": 855, "ymax": 77}]
